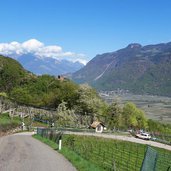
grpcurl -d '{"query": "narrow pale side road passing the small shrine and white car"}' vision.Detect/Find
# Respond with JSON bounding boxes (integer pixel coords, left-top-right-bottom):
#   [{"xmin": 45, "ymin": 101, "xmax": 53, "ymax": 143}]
[{"xmin": 64, "ymin": 131, "xmax": 171, "ymax": 151}]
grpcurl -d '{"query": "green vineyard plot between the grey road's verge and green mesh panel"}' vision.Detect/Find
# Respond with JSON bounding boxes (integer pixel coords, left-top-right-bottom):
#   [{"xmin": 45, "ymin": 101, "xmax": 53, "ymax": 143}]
[{"xmin": 63, "ymin": 135, "xmax": 145, "ymax": 171}]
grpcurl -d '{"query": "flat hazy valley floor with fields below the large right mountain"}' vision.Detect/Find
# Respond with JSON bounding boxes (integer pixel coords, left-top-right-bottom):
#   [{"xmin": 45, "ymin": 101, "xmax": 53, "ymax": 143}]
[{"xmin": 102, "ymin": 93, "xmax": 171, "ymax": 123}]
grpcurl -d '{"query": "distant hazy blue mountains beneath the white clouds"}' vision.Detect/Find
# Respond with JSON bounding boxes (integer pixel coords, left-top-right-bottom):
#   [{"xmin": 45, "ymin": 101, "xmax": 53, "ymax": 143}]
[{"xmin": 16, "ymin": 54, "xmax": 84, "ymax": 75}]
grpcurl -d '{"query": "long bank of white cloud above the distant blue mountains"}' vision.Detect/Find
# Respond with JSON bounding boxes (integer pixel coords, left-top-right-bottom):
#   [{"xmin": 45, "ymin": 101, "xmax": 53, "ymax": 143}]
[{"xmin": 0, "ymin": 39, "xmax": 87, "ymax": 64}]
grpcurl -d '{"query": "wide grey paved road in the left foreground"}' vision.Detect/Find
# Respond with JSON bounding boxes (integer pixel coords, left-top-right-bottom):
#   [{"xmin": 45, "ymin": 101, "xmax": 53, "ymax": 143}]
[{"xmin": 0, "ymin": 133, "xmax": 76, "ymax": 171}]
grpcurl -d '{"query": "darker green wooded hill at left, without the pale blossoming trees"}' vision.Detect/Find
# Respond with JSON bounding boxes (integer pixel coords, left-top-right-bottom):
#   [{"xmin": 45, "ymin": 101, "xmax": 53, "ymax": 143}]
[{"xmin": 0, "ymin": 56, "xmax": 78, "ymax": 107}]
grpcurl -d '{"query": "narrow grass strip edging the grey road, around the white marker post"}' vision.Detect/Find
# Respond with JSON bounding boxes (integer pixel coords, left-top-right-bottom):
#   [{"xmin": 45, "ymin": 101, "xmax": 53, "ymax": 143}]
[{"xmin": 33, "ymin": 135, "xmax": 103, "ymax": 171}]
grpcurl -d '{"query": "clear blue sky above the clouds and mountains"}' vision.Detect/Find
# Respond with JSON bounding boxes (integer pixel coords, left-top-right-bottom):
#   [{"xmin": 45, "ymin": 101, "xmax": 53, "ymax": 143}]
[{"xmin": 0, "ymin": 0, "xmax": 171, "ymax": 59}]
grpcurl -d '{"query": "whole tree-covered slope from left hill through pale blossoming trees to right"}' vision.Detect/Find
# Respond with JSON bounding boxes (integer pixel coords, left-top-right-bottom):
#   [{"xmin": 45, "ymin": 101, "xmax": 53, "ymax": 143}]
[{"xmin": 0, "ymin": 56, "xmax": 170, "ymax": 134}]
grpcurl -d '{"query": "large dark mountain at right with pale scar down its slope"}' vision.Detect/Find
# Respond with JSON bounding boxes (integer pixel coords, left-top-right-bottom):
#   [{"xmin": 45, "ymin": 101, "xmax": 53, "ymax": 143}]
[{"xmin": 72, "ymin": 42, "xmax": 171, "ymax": 96}]
